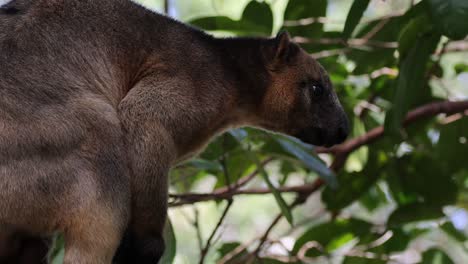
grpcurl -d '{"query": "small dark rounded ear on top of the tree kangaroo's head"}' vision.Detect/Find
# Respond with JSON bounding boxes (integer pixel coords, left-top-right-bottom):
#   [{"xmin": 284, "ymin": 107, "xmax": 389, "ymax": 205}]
[{"xmin": 268, "ymin": 31, "xmax": 299, "ymax": 66}]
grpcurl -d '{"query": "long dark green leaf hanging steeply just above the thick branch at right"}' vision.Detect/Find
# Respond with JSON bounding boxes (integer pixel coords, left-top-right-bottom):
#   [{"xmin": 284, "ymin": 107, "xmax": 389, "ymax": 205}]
[{"xmin": 385, "ymin": 32, "xmax": 440, "ymax": 135}]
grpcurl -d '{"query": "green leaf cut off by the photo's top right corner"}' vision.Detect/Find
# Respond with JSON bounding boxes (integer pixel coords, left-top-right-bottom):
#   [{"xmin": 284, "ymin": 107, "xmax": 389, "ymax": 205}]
[{"xmin": 427, "ymin": 0, "xmax": 468, "ymax": 39}]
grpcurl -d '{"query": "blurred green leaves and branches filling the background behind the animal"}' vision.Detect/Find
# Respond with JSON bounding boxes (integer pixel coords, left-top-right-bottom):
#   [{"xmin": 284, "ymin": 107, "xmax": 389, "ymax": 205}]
[{"xmin": 50, "ymin": 0, "xmax": 468, "ymax": 264}]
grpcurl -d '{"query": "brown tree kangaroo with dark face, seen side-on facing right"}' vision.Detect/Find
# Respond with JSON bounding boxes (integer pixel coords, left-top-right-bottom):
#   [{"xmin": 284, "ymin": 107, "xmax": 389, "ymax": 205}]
[{"xmin": 0, "ymin": 0, "xmax": 348, "ymax": 264}]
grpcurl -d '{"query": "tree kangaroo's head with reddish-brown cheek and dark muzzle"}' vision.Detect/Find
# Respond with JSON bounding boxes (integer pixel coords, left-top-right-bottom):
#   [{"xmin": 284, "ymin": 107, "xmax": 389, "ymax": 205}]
[{"xmin": 260, "ymin": 33, "xmax": 349, "ymax": 146}]
